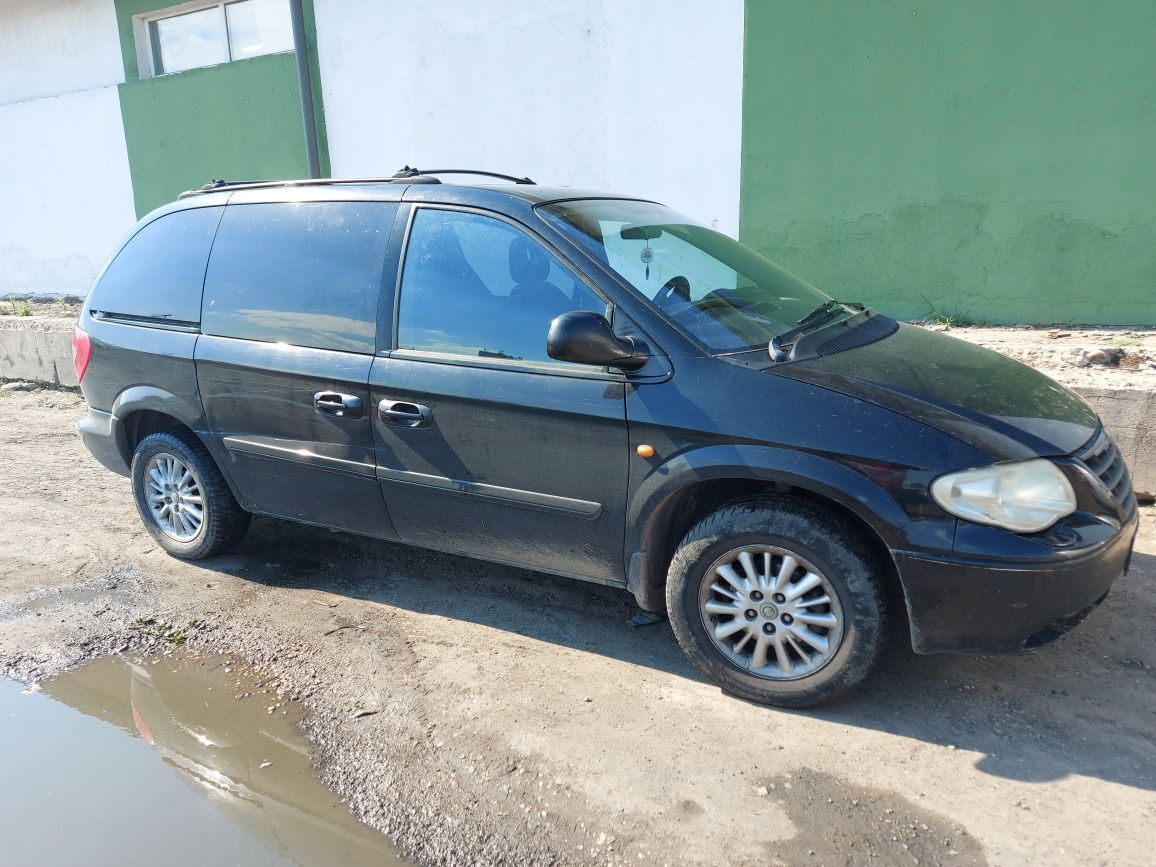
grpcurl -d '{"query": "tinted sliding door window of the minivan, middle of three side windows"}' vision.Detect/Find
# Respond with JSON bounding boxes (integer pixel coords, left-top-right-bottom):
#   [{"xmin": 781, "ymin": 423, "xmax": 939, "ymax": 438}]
[{"xmin": 201, "ymin": 202, "xmax": 398, "ymax": 354}]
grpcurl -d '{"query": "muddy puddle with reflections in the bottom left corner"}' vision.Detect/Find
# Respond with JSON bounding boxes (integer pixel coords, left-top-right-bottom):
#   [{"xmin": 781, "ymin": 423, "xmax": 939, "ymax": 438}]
[{"xmin": 0, "ymin": 654, "xmax": 401, "ymax": 866}]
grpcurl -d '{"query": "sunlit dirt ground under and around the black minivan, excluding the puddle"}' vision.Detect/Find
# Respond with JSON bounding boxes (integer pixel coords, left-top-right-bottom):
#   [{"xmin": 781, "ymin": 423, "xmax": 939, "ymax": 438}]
[{"xmin": 0, "ymin": 391, "xmax": 1156, "ymax": 865}]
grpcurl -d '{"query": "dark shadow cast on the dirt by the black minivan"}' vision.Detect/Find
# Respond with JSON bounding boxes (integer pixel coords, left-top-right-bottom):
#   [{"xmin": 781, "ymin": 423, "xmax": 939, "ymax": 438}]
[{"xmin": 205, "ymin": 519, "xmax": 1156, "ymax": 791}]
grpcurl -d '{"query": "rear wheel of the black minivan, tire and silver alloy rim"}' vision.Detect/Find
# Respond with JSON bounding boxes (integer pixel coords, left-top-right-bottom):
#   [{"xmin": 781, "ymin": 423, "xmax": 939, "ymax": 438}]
[{"xmin": 132, "ymin": 431, "xmax": 252, "ymax": 560}]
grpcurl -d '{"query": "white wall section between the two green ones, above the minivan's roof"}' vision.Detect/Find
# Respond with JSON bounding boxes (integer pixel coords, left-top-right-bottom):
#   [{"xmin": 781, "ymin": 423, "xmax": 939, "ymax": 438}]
[{"xmin": 314, "ymin": 0, "xmax": 743, "ymax": 235}]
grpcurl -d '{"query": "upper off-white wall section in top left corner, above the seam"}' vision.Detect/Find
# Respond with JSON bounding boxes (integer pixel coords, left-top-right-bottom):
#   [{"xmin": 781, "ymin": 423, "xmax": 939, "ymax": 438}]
[{"xmin": 0, "ymin": 0, "xmax": 125, "ymax": 105}]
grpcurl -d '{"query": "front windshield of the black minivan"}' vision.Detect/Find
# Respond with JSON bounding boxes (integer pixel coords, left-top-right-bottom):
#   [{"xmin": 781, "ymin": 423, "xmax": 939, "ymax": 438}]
[{"xmin": 540, "ymin": 199, "xmax": 830, "ymax": 353}]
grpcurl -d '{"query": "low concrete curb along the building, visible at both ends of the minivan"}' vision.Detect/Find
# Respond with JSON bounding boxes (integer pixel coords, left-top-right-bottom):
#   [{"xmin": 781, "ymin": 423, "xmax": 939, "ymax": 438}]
[{"xmin": 0, "ymin": 317, "xmax": 1156, "ymax": 495}]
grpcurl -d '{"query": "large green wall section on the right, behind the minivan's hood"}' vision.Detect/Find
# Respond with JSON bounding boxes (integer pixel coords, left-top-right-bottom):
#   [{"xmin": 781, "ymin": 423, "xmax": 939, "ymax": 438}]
[{"xmin": 740, "ymin": 0, "xmax": 1156, "ymax": 325}]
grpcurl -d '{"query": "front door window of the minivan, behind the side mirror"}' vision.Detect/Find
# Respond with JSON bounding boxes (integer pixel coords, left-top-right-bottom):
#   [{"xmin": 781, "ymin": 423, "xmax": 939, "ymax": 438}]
[{"xmin": 398, "ymin": 208, "xmax": 606, "ymax": 362}]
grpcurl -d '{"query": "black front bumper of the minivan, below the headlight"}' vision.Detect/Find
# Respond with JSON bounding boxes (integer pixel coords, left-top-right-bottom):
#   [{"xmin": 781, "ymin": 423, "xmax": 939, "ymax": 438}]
[{"xmin": 895, "ymin": 517, "xmax": 1139, "ymax": 653}]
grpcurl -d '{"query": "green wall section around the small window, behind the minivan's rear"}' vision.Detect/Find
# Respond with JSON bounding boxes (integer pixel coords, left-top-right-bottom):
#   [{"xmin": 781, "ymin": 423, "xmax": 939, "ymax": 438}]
[{"xmin": 116, "ymin": 0, "xmax": 329, "ymax": 215}]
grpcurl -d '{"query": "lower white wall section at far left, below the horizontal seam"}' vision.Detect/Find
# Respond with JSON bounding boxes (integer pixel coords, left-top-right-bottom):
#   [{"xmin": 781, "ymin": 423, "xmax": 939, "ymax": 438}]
[{"xmin": 0, "ymin": 87, "xmax": 136, "ymax": 296}]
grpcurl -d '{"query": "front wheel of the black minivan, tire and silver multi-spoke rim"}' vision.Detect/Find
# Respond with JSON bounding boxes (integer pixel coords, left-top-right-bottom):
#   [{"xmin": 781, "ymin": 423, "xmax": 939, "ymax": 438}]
[{"xmin": 666, "ymin": 497, "xmax": 887, "ymax": 707}]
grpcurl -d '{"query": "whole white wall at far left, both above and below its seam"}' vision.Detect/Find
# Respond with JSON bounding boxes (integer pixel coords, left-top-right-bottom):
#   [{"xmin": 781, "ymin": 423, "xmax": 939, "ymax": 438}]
[{"xmin": 0, "ymin": 0, "xmax": 136, "ymax": 296}]
